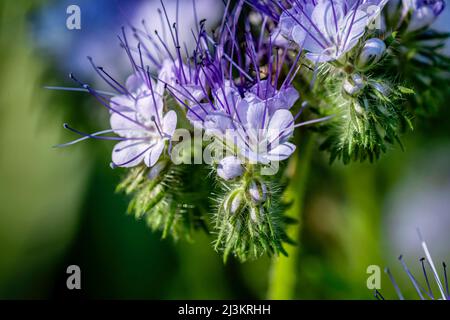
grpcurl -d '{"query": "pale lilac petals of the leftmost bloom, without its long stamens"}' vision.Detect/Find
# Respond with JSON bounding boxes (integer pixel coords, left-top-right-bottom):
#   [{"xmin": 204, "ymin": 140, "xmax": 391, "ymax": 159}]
[{"xmin": 110, "ymin": 74, "xmax": 177, "ymax": 167}]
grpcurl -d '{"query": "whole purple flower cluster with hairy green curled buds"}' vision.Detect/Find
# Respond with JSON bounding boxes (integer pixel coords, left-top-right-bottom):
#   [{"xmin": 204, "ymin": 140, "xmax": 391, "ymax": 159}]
[{"xmin": 56, "ymin": 0, "xmax": 450, "ymax": 261}]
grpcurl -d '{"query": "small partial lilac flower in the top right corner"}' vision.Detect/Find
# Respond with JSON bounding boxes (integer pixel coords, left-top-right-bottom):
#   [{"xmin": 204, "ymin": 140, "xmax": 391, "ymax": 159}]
[{"xmin": 403, "ymin": 0, "xmax": 445, "ymax": 31}]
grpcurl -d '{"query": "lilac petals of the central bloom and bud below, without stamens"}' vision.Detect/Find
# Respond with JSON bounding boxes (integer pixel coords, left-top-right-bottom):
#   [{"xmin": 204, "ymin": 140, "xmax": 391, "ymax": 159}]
[{"xmin": 187, "ymin": 81, "xmax": 299, "ymax": 180}]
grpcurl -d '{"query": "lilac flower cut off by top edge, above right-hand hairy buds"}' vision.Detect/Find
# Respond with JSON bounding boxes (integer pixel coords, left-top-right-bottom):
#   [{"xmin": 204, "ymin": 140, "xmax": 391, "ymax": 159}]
[{"xmin": 268, "ymin": 0, "xmax": 387, "ymax": 63}]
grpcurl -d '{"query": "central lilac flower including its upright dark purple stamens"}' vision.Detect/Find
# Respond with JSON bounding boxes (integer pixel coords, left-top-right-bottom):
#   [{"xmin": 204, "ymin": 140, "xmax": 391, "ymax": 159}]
[{"xmin": 178, "ymin": 22, "xmax": 332, "ymax": 180}]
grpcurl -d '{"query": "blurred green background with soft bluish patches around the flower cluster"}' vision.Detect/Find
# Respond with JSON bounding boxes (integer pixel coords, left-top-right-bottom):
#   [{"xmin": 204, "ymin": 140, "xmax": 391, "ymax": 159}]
[{"xmin": 0, "ymin": 0, "xmax": 450, "ymax": 299}]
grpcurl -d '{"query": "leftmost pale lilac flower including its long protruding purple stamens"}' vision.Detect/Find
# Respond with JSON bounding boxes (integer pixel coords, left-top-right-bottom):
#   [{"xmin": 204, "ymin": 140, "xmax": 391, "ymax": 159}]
[{"xmin": 61, "ymin": 38, "xmax": 177, "ymax": 168}]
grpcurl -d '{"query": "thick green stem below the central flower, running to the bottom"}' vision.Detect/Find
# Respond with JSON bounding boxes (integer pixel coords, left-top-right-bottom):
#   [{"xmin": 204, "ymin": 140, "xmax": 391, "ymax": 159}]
[{"xmin": 267, "ymin": 136, "xmax": 314, "ymax": 300}]
